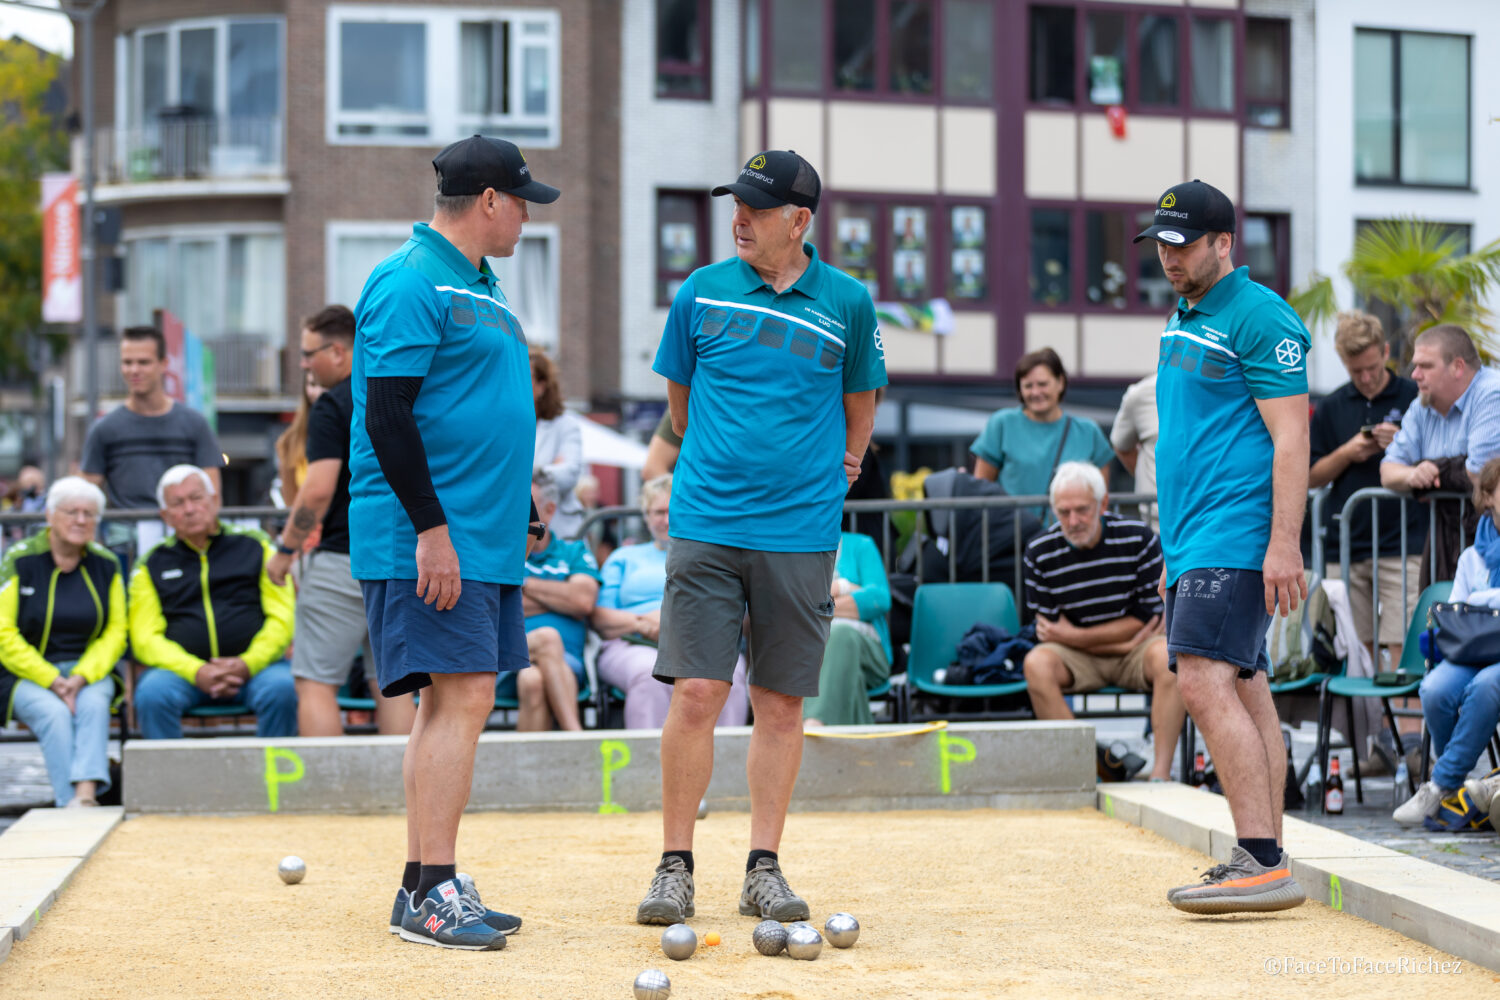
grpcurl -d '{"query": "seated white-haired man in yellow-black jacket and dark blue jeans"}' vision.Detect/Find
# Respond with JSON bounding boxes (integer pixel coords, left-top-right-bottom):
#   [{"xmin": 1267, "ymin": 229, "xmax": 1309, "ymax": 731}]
[{"xmin": 129, "ymin": 465, "xmax": 297, "ymax": 739}]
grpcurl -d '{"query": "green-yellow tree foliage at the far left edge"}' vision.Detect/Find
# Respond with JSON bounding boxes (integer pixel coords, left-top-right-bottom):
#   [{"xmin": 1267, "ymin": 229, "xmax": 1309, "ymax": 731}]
[{"xmin": 0, "ymin": 39, "xmax": 68, "ymax": 373}]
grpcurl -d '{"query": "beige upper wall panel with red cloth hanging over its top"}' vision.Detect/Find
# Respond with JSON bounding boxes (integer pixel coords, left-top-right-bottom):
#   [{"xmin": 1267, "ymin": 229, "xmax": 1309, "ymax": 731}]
[{"xmin": 1080, "ymin": 114, "xmax": 1185, "ymax": 204}]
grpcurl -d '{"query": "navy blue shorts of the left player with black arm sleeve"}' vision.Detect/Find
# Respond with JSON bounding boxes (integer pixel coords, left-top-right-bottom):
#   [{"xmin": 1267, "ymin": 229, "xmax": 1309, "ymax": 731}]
[{"xmin": 360, "ymin": 580, "xmax": 530, "ymax": 697}]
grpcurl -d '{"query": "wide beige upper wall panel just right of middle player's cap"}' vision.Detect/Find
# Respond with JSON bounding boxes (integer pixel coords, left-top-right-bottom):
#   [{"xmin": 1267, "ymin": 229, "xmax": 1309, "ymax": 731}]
[{"xmin": 827, "ymin": 100, "xmax": 938, "ymax": 195}]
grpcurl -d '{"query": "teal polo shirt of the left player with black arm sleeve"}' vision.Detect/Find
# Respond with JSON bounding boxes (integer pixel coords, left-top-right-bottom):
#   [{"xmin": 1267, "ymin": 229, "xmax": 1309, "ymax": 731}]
[{"xmin": 350, "ymin": 222, "xmax": 537, "ymax": 585}]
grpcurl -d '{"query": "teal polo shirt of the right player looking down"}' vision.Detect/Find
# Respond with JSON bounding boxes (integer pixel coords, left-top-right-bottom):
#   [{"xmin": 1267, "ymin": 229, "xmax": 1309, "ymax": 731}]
[{"xmin": 1157, "ymin": 267, "xmax": 1310, "ymax": 583}]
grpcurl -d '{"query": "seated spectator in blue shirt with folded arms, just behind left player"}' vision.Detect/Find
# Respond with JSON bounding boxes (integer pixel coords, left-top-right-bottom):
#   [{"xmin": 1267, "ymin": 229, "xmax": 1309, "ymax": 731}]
[{"xmin": 495, "ymin": 469, "xmax": 599, "ymax": 732}]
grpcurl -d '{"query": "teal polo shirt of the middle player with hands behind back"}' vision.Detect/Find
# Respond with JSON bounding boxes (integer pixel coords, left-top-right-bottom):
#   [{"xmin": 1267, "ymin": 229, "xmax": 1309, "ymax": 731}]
[{"xmin": 653, "ymin": 243, "xmax": 885, "ymax": 552}]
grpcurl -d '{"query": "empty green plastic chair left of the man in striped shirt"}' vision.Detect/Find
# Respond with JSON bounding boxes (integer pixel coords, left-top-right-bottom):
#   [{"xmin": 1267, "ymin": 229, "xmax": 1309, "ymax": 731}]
[{"xmin": 905, "ymin": 583, "xmax": 1026, "ymax": 720}]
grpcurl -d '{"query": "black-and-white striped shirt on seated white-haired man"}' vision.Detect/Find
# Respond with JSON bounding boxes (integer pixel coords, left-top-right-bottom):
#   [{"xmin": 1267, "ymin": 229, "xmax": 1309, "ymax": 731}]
[{"xmin": 1022, "ymin": 513, "xmax": 1163, "ymax": 628}]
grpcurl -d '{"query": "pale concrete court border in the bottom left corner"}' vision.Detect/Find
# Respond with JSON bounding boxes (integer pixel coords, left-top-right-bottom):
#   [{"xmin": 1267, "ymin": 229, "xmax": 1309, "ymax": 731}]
[{"xmin": 0, "ymin": 805, "xmax": 125, "ymax": 961}]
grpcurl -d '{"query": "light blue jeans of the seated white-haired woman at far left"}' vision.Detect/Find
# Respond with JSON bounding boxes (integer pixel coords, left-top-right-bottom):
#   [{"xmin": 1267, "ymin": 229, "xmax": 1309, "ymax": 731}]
[{"xmin": 11, "ymin": 661, "xmax": 114, "ymax": 807}]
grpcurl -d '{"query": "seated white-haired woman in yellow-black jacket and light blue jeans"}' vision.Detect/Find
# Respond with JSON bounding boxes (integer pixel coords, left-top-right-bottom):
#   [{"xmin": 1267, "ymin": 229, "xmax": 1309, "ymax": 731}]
[{"xmin": 0, "ymin": 475, "xmax": 126, "ymax": 807}]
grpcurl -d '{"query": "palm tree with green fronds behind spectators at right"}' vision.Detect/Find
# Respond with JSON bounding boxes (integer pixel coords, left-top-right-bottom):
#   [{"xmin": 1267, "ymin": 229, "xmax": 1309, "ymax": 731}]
[{"xmin": 1287, "ymin": 217, "xmax": 1500, "ymax": 364}]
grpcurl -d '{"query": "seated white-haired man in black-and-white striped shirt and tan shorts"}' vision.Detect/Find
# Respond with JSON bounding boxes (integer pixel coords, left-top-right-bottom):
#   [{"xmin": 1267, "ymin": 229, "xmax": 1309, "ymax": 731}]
[{"xmin": 1023, "ymin": 462, "xmax": 1184, "ymax": 781}]
